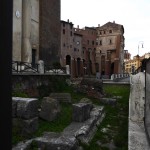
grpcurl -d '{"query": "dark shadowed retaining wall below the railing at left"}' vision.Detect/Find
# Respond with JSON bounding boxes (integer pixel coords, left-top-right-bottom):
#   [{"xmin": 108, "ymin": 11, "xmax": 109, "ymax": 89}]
[{"xmin": 12, "ymin": 74, "xmax": 70, "ymax": 97}]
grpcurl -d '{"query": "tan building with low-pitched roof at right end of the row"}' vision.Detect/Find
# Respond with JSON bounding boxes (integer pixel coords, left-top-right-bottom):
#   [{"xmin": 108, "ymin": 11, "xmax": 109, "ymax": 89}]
[{"xmin": 96, "ymin": 22, "xmax": 124, "ymax": 76}]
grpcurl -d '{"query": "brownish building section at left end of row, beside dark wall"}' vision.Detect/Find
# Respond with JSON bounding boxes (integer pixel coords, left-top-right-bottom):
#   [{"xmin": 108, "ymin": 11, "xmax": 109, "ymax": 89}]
[{"xmin": 60, "ymin": 19, "xmax": 83, "ymax": 77}]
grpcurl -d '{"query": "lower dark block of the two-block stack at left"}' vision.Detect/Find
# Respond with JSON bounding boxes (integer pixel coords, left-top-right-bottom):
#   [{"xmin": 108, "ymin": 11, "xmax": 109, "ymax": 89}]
[{"xmin": 13, "ymin": 117, "xmax": 39, "ymax": 135}]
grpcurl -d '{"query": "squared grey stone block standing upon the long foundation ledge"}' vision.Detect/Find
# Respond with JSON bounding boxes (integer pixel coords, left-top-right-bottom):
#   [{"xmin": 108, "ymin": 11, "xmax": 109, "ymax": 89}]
[{"xmin": 72, "ymin": 103, "xmax": 92, "ymax": 122}]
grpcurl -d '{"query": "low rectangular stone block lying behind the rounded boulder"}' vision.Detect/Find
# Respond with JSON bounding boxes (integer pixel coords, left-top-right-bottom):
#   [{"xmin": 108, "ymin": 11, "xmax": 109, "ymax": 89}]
[{"xmin": 50, "ymin": 93, "xmax": 71, "ymax": 103}]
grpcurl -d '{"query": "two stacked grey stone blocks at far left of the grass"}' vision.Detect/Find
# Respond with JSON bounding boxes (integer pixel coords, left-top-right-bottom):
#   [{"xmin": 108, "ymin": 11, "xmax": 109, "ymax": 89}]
[{"xmin": 12, "ymin": 97, "xmax": 38, "ymax": 135}]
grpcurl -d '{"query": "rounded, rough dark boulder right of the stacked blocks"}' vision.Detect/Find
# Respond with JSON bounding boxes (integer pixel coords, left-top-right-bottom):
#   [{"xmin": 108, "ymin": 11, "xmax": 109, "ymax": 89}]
[{"xmin": 39, "ymin": 97, "xmax": 60, "ymax": 121}]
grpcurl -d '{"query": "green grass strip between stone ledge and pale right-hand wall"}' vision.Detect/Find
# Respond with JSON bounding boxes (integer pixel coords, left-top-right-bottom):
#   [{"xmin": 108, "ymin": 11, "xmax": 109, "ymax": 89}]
[{"xmin": 82, "ymin": 85, "xmax": 130, "ymax": 150}]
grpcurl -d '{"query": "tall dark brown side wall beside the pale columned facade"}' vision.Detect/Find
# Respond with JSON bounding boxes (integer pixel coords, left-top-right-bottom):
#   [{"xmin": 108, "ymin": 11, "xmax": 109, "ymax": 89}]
[{"xmin": 39, "ymin": 0, "xmax": 61, "ymax": 65}]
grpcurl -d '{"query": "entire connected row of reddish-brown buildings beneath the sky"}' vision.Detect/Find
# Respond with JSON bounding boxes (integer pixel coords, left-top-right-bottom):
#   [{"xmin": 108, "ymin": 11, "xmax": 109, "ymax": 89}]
[{"xmin": 61, "ymin": 20, "xmax": 124, "ymax": 78}]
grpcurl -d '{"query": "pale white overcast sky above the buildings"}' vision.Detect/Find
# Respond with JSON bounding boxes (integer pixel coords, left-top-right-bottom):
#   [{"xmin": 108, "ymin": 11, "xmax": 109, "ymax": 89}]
[{"xmin": 61, "ymin": 0, "xmax": 150, "ymax": 57}]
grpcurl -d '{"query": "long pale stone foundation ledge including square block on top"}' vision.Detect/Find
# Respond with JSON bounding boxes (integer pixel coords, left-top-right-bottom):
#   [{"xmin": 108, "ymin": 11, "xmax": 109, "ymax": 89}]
[{"xmin": 12, "ymin": 101, "xmax": 105, "ymax": 150}]
